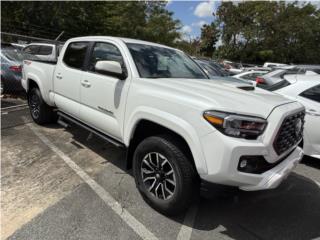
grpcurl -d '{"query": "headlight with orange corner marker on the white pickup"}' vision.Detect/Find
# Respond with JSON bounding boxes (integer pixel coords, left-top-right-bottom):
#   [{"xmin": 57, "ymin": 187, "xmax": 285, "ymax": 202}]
[{"xmin": 203, "ymin": 111, "xmax": 267, "ymax": 139}]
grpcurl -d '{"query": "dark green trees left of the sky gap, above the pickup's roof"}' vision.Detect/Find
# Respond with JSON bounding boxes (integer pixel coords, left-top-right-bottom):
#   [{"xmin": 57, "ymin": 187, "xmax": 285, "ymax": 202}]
[{"xmin": 1, "ymin": 1, "xmax": 180, "ymax": 45}]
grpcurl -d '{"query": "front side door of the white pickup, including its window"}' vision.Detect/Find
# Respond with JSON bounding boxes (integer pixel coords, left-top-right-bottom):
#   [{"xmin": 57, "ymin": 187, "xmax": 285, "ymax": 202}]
[{"xmin": 80, "ymin": 42, "xmax": 129, "ymax": 140}]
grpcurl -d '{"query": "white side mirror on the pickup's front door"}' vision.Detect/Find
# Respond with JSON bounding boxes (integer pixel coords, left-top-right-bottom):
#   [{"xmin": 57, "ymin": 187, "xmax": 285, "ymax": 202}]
[{"xmin": 94, "ymin": 61, "xmax": 127, "ymax": 80}]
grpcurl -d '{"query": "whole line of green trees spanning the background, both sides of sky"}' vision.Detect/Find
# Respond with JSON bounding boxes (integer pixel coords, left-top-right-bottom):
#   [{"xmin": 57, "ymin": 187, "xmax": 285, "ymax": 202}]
[{"xmin": 1, "ymin": 1, "xmax": 320, "ymax": 63}]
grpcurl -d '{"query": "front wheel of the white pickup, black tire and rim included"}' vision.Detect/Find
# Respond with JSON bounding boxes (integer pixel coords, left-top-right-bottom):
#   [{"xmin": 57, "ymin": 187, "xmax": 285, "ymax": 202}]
[{"xmin": 133, "ymin": 135, "xmax": 199, "ymax": 215}]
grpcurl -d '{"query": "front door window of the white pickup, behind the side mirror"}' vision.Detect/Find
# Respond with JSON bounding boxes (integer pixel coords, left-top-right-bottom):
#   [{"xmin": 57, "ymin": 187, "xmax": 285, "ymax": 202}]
[{"xmin": 89, "ymin": 43, "xmax": 125, "ymax": 72}]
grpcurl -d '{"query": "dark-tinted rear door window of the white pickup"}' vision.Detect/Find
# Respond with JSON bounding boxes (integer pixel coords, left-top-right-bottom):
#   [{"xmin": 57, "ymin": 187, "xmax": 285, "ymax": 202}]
[{"xmin": 63, "ymin": 42, "xmax": 88, "ymax": 69}]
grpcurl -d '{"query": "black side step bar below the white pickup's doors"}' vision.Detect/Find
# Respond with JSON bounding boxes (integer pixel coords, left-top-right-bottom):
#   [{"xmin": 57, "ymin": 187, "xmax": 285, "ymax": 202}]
[{"xmin": 57, "ymin": 111, "xmax": 126, "ymax": 148}]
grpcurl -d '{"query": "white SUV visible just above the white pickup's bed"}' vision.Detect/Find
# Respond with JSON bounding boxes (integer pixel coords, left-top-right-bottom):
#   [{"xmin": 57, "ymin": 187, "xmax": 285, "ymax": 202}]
[{"xmin": 22, "ymin": 43, "xmax": 59, "ymax": 62}]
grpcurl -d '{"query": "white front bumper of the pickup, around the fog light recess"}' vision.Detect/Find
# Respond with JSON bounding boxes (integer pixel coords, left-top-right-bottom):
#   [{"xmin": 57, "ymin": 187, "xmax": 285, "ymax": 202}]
[{"xmin": 200, "ymin": 103, "xmax": 303, "ymax": 191}]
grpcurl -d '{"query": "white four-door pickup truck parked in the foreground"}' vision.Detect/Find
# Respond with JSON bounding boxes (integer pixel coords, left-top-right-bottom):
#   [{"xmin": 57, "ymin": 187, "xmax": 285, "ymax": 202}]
[{"xmin": 22, "ymin": 37, "xmax": 305, "ymax": 214}]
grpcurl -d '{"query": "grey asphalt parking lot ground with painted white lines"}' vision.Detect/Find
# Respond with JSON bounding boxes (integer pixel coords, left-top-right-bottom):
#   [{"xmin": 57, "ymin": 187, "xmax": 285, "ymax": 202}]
[{"xmin": 1, "ymin": 105, "xmax": 320, "ymax": 240}]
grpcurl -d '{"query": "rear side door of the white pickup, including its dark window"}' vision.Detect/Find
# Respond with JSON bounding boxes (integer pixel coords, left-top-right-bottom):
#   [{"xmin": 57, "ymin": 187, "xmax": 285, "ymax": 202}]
[{"xmin": 53, "ymin": 42, "xmax": 89, "ymax": 118}]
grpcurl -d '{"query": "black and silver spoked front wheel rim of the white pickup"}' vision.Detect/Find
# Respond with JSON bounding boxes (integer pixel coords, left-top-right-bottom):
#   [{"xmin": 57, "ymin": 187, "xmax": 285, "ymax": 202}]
[{"xmin": 141, "ymin": 152, "xmax": 177, "ymax": 200}]
